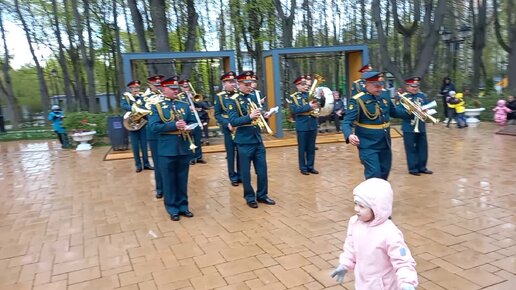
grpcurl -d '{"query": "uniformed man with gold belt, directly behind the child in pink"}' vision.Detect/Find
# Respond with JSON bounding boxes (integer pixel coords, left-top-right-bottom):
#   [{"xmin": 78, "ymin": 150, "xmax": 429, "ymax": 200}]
[{"xmin": 342, "ymin": 72, "xmax": 406, "ymax": 180}]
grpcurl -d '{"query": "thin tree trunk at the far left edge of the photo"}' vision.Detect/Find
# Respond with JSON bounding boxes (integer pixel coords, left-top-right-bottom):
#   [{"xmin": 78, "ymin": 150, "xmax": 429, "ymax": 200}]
[{"xmin": 0, "ymin": 13, "xmax": 22, "ymax": 129}]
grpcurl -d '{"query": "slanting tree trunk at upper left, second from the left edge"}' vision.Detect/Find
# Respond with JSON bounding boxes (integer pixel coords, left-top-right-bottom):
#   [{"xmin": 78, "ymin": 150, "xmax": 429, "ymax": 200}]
[{"xmin": 14, "ymin": 0, "xmax": 50, "ymax": 120}]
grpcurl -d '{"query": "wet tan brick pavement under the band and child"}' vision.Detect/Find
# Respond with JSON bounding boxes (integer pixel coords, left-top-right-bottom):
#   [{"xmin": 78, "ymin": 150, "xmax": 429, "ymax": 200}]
[{"xmin": 0, "ymin": 123, "xmax": 516, "ymax": 290}]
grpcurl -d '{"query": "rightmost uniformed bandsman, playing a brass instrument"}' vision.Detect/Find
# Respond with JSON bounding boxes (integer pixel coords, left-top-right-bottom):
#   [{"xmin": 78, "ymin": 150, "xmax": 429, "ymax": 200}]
[{"xmin": 401, "ymin": 77, "xmax": 433, "ymax": 176}]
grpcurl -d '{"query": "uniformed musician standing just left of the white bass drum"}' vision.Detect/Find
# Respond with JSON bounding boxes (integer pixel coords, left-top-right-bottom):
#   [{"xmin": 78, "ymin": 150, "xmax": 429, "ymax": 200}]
[{"xmin": 286, "ymin": 75, "xmax": 319, "ymax": 175}]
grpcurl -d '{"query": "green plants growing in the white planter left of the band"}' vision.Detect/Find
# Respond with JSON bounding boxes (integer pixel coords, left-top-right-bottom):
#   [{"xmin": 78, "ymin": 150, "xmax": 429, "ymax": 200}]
[{"xmin": 63, "ymin": 112, "xmax": 108, "ymax": 136}]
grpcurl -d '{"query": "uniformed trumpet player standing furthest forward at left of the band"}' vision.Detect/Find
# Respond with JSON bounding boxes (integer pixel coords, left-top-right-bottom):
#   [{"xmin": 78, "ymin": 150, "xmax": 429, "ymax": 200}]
[{"xmin": 149, "ymin": 76, "xmax": 196, "ymax": 221}]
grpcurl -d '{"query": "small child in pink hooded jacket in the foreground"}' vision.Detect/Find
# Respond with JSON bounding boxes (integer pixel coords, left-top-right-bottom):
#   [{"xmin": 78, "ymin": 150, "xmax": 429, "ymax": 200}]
[{"xmin": 331, "ymin": 178, "xmax": 418, "ymax": 290}]
